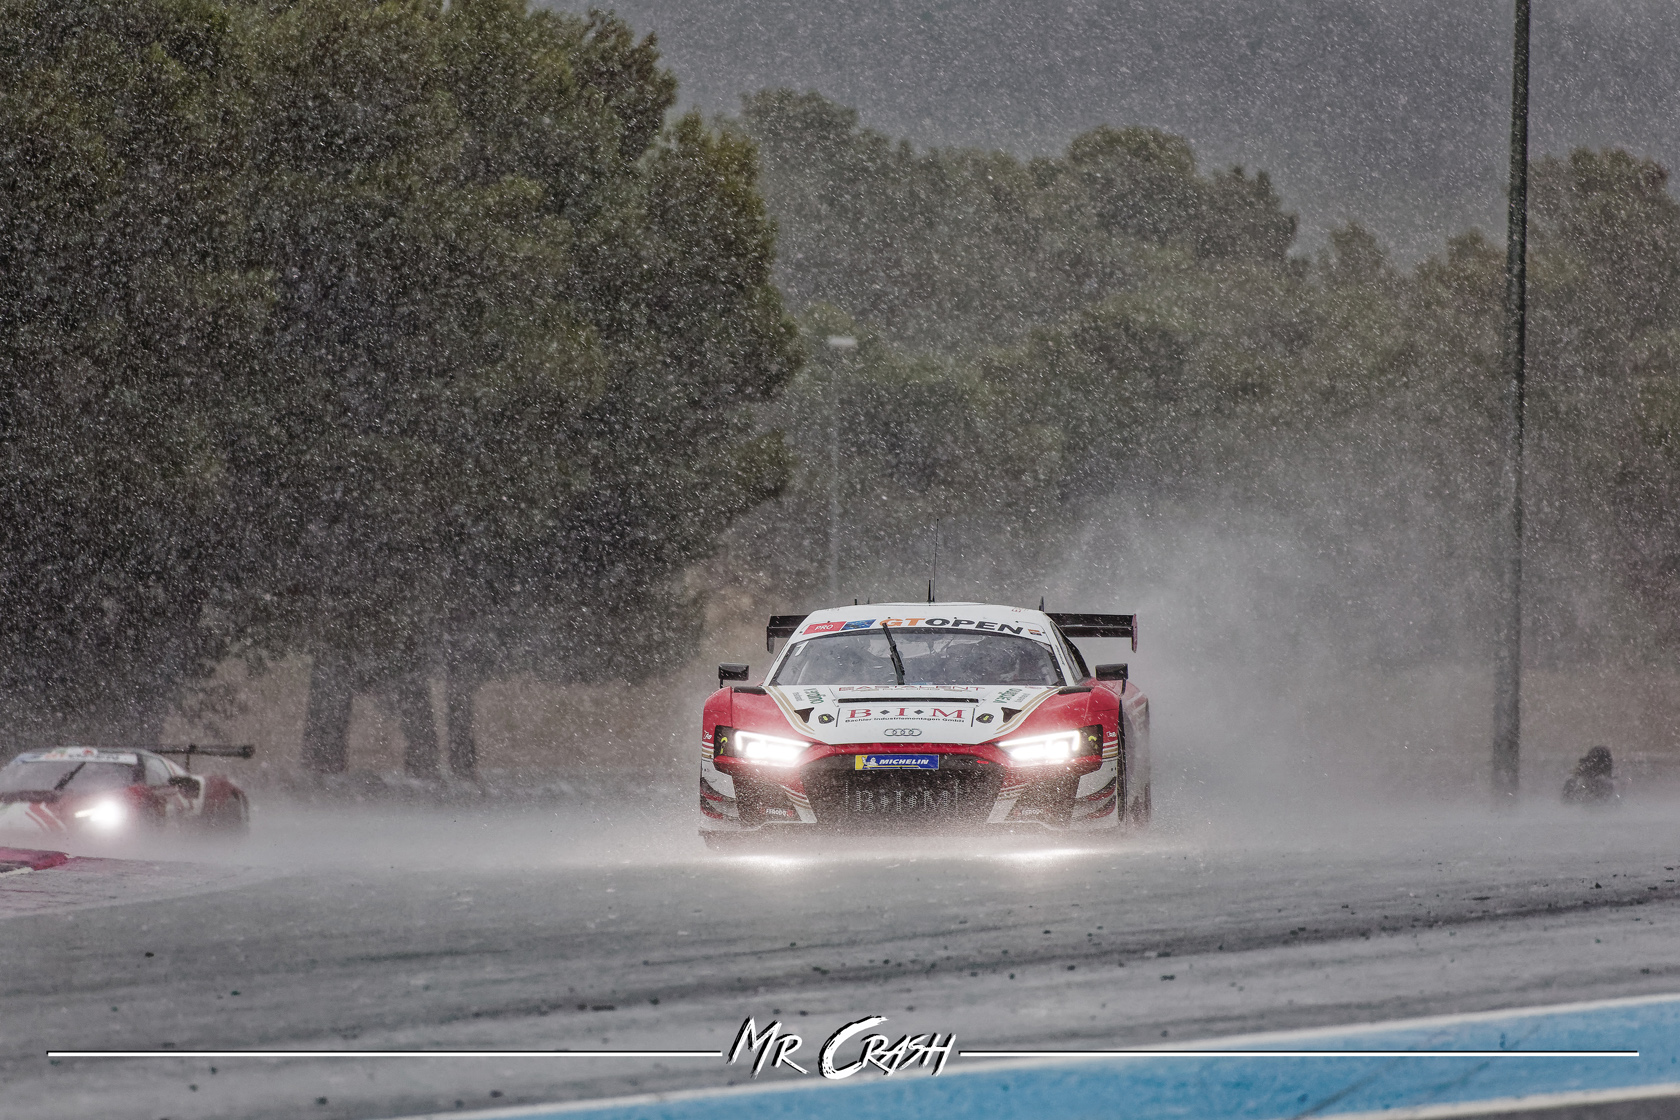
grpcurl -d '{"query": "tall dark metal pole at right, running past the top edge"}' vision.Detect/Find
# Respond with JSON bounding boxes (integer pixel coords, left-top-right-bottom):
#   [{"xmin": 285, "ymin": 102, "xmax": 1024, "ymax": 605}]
[{"xmin": 1494, "ymin": 0, "xmax": 1530, "ymax": 799}]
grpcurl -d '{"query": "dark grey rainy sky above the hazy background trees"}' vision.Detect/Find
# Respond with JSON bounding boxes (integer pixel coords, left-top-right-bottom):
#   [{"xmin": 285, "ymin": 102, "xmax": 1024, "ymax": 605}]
[{"xmin": 564, "ymin": 0, "xmax": 1680, "ymax": 257}]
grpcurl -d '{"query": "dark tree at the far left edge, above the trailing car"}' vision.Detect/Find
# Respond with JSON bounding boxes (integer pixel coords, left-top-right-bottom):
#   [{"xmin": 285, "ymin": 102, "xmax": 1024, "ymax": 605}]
[{"xmin": 0, "ymin": 0, "xmax": 264, "ymax": 742}]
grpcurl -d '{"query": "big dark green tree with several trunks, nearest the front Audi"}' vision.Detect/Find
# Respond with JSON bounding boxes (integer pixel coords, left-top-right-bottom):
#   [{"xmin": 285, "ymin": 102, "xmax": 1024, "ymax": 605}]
[{"xmin": 230, "ymin": 0, "xmax": 795, "ymax": 774}]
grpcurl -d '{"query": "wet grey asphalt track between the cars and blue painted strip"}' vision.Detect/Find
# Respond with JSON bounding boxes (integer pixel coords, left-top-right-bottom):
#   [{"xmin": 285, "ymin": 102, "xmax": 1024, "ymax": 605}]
[{"xmin": 0, "ymin": 792, "xmax": 1680, "ymax": 1120}]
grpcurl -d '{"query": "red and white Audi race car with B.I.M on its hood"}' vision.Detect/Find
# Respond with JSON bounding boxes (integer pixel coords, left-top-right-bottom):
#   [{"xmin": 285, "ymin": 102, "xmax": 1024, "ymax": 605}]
[{"xmin": 701, "ymin": 603, "xmax": 1149, "ymax": 846}]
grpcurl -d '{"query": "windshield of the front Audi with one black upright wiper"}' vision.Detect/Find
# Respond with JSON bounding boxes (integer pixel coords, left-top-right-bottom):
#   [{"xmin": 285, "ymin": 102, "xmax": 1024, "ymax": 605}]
[{"xmin": 771, "ymin": 626, "xmax": 1062, "ymax": 685}]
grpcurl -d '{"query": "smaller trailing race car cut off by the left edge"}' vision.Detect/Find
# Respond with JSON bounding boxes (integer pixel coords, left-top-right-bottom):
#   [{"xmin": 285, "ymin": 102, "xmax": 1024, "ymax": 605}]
[{"xmin": 0, "ymin": 747, "xmax": 252, "ymax": 838}]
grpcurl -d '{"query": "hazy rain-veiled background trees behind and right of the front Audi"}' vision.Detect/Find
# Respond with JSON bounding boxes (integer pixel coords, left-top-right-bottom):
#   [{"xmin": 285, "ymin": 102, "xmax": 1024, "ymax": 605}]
[{"xmin": 738, "ymin": 91, "xmax": 1680, "ymax": 671}]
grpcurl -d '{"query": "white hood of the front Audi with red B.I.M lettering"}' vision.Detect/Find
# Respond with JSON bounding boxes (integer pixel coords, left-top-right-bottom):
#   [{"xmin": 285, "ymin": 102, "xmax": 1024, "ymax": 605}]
[{"xmin": 764, "ymin": 685, "xmax": 1060, "ymax": 747}]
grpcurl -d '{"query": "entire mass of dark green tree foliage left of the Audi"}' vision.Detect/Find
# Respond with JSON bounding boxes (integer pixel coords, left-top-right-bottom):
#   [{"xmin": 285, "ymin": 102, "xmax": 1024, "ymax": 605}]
[{"xmin": 0, "ymin": 0, "xmax": 796, "ymax": 752}]
